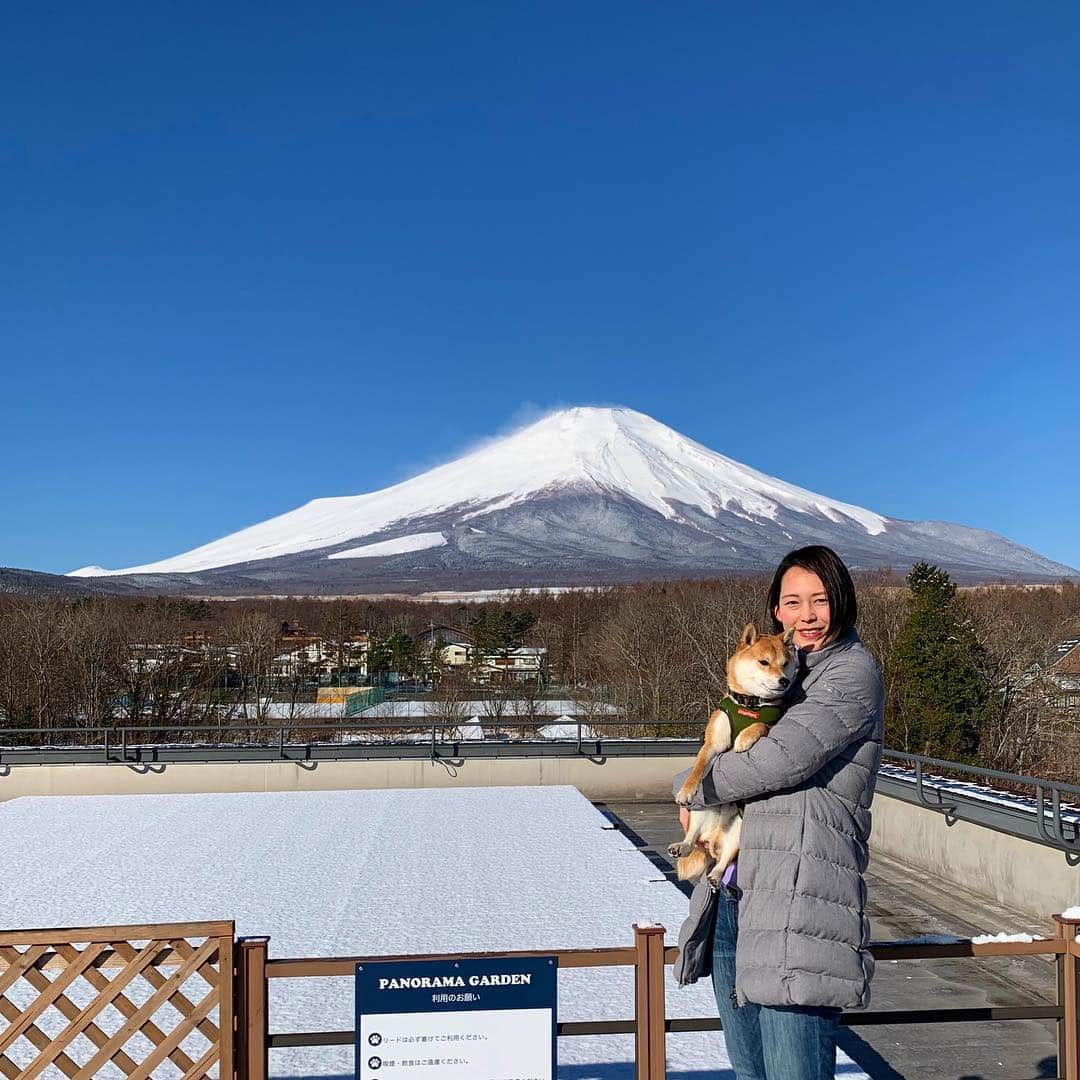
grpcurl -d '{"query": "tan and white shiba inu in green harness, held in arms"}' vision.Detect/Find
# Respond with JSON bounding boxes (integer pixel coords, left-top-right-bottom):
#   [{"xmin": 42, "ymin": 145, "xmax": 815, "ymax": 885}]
[{"xmin": 667, "ymin": 622, "xmax": 798, "ymax": 889}]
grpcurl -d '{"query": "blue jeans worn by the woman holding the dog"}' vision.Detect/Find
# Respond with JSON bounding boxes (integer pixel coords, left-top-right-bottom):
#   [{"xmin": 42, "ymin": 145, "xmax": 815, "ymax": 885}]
[{"xmin": 713, "ymin": 889, "xmax": 840, "ymax": 1080}]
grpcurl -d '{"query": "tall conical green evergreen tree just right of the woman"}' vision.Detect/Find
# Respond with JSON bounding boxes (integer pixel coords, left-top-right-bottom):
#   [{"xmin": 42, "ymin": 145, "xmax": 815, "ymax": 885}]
[{"xmin": 886, "ymin": 563, "xmax": 990, "ymax": 761}]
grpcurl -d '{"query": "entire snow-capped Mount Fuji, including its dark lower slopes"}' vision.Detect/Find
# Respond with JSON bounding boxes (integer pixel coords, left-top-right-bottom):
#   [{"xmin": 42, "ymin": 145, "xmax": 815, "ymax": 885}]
[{"xmin": 69, "ymin": 407, "xmax": 1077, "ymax": 595}]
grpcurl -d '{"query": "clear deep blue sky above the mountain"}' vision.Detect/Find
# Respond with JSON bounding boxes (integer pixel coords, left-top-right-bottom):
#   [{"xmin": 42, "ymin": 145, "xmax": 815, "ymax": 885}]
[{"xmin": 0, "ymin": 0, "xmax": 1080, "ymax": 571}]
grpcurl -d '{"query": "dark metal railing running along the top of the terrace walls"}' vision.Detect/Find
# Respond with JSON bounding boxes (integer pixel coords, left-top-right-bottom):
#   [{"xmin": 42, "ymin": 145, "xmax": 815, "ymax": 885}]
[{"xmin": 0, "ymin": 716, "xmax": 1080, "ymax": 865}]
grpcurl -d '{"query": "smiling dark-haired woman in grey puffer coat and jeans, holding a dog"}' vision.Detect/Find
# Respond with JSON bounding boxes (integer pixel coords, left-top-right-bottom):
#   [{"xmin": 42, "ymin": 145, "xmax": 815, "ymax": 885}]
[{"xmin": 674, "ymin": 546, "xmax": 883, "ymax": 1080}]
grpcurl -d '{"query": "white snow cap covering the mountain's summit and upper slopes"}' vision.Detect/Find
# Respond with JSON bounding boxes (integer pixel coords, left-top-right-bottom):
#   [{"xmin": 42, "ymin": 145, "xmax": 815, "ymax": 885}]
[{"xmin": 72, "ymin": 406, "xmax": 887, "ymax": 577}]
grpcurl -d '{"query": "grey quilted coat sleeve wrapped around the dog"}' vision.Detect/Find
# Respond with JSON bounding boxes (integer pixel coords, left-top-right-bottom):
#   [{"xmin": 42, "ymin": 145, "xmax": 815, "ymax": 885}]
[{"xmin": 673, "ymin": 653, "xmax": 883, "ymax": 810}]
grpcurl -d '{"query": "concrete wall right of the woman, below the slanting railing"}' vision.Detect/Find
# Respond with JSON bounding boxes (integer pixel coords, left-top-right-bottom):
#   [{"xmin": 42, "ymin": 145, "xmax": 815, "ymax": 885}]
[{"xmin": 870, "ymin": 795, "xmax": 1080, "ymax": 930}]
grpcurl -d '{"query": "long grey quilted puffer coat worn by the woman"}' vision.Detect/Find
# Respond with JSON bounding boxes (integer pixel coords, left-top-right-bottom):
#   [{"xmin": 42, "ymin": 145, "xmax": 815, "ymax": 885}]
[{"xmin": 673, "ymin": 631, "xmax": 885, "ymax": 1009}]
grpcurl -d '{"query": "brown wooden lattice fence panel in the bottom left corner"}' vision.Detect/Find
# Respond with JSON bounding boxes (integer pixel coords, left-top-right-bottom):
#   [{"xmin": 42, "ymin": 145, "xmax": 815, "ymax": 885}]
[{"xmin": 0, "ymin": 922, "xmax": 233, "ymax": 1080}]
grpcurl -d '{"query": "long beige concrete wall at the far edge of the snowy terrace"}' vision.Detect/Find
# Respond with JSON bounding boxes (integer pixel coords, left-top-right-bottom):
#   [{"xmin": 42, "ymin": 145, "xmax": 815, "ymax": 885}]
[{"xmin": 0, "ymin": 757, "xmax": 693, "ymax": 801}]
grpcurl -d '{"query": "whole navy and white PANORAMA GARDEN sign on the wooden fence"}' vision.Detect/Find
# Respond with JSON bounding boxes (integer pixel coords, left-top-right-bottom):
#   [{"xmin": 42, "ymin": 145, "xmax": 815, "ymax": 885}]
[{"xmin": 356, "ymin": 956, "xmax": 558, "ymax": 1080}]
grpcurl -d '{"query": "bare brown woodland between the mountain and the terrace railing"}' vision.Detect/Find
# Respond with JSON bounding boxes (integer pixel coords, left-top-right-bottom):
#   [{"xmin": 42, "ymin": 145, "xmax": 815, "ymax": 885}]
[{"xmin": 0, "ymin": 583, "xmax": 1080, "ymax": 780}]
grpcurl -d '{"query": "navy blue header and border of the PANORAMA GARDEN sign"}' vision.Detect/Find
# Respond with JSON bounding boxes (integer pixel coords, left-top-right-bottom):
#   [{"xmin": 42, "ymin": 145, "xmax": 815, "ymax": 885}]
[{"xmin": 353, "ymin": 956, "xmax": 558, "ymax": 1080}]
